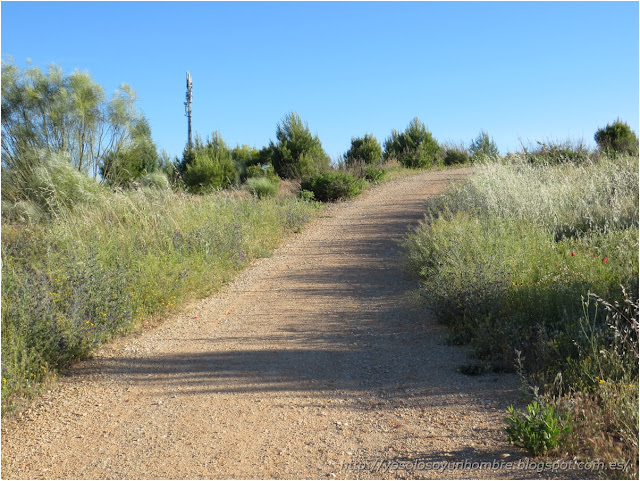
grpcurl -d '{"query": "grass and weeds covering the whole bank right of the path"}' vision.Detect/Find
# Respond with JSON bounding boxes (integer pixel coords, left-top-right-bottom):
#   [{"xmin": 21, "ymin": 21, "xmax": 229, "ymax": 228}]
[{"xmin": 405, "ymin": 120, "xmax": 638, "ymax": 477}]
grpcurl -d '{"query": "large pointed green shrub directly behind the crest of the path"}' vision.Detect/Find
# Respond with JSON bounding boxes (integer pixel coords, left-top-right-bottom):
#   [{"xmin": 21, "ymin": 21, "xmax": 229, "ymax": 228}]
[{"xmin": 384, "ymin": 117, "xmax": 440, "ymax": 168}]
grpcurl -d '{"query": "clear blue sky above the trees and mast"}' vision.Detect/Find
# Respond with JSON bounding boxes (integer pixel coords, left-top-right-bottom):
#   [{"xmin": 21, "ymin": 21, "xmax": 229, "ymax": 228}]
[{"xmin": 1, "ymin": 1, "xmax": 639, "ymax": 158}]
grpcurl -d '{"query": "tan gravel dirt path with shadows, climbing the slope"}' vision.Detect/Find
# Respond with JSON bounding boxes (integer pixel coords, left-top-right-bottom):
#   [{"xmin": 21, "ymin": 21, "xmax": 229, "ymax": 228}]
[{"xmin": 2, "ymin": 169, "xmax": 540, "ymax": 479}]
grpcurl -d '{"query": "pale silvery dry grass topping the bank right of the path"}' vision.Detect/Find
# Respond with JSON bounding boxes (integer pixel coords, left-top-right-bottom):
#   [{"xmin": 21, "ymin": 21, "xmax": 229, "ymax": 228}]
[{"xmin": 424, "ymin": 155, "xmax": 638, "ymax": 238}]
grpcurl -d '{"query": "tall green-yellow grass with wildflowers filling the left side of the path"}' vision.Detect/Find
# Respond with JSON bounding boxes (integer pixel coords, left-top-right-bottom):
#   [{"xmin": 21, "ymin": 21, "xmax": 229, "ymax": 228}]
[{"xmin": 2, "ymin": 189, "xmax": 315, "ymax": 408}]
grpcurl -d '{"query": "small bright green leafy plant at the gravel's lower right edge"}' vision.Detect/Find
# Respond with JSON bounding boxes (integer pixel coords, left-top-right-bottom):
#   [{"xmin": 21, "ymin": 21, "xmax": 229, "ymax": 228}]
[{"xmin": 505, "ymin": 401, "xmax": 571, "ymax": 456}]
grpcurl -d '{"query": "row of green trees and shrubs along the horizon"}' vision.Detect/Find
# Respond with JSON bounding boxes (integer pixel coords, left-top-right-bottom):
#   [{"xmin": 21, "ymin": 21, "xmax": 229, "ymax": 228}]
[{"xmin": 2, "ymin": 60, "xmax": 638, "ymax": 209}]
